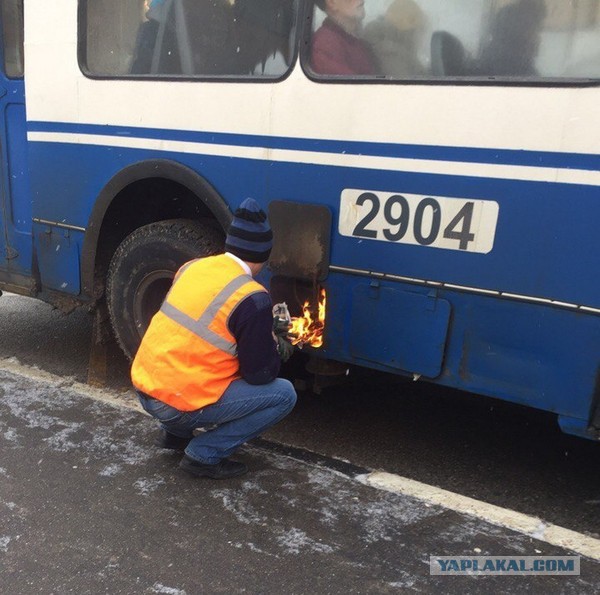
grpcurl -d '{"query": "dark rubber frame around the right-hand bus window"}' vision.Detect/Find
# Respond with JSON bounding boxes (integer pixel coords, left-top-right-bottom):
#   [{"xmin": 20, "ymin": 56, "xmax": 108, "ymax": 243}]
[{"xmin": 299, "ymin": 0, "xmax": 600, "ymax": 88}]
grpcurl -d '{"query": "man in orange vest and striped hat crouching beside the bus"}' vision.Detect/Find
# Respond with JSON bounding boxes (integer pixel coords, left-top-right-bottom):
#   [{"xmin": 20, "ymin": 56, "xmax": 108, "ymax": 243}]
[{"xmin": 131, "ymin": 198, "xmax": 296, "ymax": 479}]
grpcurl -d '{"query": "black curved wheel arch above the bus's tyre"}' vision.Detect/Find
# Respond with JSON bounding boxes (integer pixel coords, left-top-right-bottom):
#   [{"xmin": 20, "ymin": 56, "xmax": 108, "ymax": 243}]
[{"xmin": 81, "ymin": 159, "xmax": 232, "ymax": 299}]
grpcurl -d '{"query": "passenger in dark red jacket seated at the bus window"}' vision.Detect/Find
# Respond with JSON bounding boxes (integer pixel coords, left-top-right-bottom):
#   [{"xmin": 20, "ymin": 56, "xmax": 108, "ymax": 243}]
[{"xmin": 310, "ymin": 0, "xmax": 377, "ymax": 75}]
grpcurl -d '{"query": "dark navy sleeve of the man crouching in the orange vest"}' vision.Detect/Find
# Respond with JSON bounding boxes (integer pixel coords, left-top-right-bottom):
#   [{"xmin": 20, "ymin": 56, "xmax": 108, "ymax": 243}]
[{"xmin": 228, "ymin": 292, "xmax": 281, "ymax": 384}]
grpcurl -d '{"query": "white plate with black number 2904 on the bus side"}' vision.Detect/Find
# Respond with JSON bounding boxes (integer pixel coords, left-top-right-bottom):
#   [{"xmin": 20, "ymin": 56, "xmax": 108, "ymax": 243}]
[{"xmin": 338, "ymin": 188, "xmax": 499, "ymax": 254}]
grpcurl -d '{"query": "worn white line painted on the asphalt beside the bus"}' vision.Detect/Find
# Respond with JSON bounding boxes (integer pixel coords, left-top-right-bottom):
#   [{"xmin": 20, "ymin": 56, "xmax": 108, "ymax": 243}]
[{"xmin": 0, "ymin": 358, "xmax": 600, "ymax": 561}]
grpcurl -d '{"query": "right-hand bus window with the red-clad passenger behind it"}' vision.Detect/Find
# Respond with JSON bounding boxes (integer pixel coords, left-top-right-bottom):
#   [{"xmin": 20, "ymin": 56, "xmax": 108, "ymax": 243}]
[{"xmin": 308, "ymin": 0, "xmax": 600, "ymax": 82}]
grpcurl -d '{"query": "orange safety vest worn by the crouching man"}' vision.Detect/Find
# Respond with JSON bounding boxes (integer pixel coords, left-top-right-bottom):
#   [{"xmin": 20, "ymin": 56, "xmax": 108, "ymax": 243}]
[{"xmin": 131, "ymin": 254, "xmax": 266, "ymax": 411}]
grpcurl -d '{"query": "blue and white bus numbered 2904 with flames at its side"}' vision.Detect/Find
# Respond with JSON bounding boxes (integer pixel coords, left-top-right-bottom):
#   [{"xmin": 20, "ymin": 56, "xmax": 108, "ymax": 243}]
[{"xmin": 0, "ymin": 0, "xmax": 600, "ymax": 439}]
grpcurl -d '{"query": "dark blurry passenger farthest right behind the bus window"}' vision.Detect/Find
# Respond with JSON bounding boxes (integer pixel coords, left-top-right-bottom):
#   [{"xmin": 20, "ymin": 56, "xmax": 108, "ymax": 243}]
[{"xmin": 477, "ymin": 0, "xmax": 546, "ymax": 76}]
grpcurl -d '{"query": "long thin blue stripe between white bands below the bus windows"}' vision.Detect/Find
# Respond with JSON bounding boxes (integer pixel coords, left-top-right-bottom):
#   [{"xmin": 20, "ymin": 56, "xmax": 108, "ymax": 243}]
[{"xmin": 28, "ymin": 121, "xmax": 600, "ymax": 171}]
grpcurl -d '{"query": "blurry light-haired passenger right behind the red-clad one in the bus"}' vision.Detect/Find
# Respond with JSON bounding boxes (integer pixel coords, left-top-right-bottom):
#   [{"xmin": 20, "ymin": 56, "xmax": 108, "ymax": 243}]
[{"xmin": 364, "ymin": 0, "xmax": 425, "ymax": 78}]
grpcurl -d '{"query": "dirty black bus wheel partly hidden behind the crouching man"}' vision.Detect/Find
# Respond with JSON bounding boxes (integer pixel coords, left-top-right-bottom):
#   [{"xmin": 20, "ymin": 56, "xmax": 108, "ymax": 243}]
[{"xmin": 106, "ymin": 219, "xmax": 224, "ymax": 359}]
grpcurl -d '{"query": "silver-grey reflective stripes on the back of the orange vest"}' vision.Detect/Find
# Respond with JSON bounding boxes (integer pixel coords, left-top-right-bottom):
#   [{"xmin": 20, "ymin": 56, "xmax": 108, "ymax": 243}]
[{"xmin": 160, "ymin": 275, "xmax": 252, "ymax": 355}]
